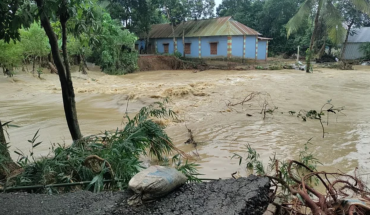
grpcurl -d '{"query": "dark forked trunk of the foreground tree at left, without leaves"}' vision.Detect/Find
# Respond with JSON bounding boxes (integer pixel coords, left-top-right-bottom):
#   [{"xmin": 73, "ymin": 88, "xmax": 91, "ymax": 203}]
[{"xmin": 36, "ymin": 0, "xmax": 82, "ymax": 141}]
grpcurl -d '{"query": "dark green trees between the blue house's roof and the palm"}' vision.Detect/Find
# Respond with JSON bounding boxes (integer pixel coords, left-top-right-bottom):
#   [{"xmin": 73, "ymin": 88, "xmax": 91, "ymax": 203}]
[{"xmin": 217, "ymin": 0, "xmax": 312, "ymax": 56}]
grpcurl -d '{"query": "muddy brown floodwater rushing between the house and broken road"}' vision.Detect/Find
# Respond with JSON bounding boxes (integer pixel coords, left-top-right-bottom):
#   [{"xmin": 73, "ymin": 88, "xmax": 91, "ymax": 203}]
[{"xmin": 0, "ymin": 66, "xmax": 370, "ymax": 178}]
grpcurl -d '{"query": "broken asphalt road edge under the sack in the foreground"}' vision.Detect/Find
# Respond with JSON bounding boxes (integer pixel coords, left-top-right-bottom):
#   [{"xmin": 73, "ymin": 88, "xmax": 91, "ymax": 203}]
[{"xmin": 0, "ymin": 176, "xmax": 269, "ymax": 215}]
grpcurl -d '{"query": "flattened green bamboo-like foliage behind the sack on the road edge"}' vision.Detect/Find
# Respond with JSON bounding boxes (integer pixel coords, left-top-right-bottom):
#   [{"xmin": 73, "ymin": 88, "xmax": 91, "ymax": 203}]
[{"xmin": 8, "ymin": 101, "xmax": 198, "ymax": 193}]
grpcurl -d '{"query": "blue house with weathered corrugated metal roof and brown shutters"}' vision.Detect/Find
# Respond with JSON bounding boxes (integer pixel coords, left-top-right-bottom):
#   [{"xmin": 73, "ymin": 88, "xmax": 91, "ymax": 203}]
[{"xmin": 136, "ymin": 16, "xmax": 271, "ymax": 60}]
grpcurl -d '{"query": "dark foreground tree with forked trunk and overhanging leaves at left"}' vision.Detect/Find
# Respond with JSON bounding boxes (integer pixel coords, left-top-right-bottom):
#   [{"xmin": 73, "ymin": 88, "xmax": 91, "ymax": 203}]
[{"xmin": 0, "ymin": 0, "xmax": 94, "ymax": 142}]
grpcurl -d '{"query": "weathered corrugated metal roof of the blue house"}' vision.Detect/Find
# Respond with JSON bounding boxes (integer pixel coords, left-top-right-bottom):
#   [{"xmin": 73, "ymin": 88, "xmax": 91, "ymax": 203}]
[{"xmin": 149, "ymin": 16, "xmax": 260, "ymax": 38}]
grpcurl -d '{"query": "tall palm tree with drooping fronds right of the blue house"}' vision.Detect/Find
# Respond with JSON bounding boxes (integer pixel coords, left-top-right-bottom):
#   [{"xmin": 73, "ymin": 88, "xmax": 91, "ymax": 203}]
[{"xmin": 286, "ymin": 0, "xmax": 370, "ymax": 73}]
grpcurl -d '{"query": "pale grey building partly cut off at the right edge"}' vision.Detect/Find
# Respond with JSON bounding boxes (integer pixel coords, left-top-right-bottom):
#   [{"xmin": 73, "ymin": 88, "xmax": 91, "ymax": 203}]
[{"xmin": 343, "ymin": 27, "xmax": 370, "ymax": 60}]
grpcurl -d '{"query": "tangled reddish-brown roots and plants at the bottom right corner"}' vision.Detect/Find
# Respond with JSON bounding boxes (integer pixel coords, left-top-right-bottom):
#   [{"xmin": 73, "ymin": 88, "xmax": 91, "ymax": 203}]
[{"xmin": 233, "ymin": 139, "xmax": 370, "ymax": 215}]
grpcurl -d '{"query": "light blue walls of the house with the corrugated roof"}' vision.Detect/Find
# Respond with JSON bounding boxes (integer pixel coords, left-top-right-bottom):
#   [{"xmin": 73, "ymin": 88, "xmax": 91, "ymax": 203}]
[{"xmin": 146, "ymin": 36, "xmax": 267, "ymax": 60}]
